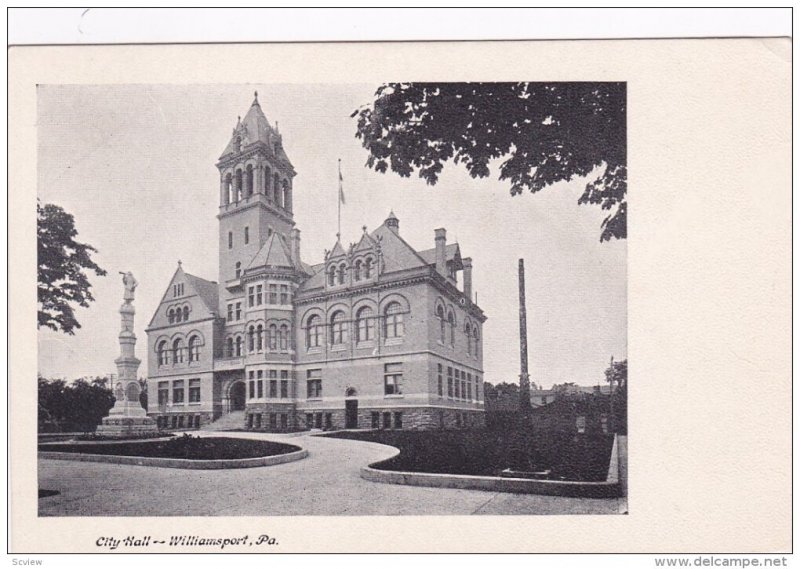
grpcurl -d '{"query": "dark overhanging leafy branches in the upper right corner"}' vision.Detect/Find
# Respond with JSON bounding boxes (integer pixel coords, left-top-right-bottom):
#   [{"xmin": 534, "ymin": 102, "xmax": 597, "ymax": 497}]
[{"xmin": 351, "ymin": 83, "xmax": 627, "ymax": 241}]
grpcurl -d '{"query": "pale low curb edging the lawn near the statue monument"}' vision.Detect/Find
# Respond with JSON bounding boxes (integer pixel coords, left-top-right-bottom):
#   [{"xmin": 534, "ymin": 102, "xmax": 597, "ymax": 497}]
[{"xmin": 39, "ymin": 449, "xmax": 308, "ymax": 470}]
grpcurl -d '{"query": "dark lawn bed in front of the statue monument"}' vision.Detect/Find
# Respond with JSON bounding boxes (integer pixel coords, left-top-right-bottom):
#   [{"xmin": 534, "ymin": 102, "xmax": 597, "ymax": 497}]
[{"xmin": 39, "ymin": 435, "xmax": 300, "ymax": 460}]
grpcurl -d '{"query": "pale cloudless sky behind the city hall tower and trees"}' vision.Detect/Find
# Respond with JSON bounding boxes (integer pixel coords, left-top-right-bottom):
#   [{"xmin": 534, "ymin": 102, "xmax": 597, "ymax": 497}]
[{"xmin": 37, "ymin": 84, "xmax": 627, "ymax": 388}]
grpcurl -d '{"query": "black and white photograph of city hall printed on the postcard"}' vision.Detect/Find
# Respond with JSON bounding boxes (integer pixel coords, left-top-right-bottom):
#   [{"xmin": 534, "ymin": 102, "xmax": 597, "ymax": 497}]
[{"xmin": 37, "ymin": 81, "xmax": 628, "ymax": 516}]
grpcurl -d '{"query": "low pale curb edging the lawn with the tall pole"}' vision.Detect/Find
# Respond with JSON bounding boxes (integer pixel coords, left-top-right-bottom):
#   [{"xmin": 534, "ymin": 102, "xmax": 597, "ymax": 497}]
[{"xmin": 361, "ymin": 436, "xmax": 621, "ymax": 498}]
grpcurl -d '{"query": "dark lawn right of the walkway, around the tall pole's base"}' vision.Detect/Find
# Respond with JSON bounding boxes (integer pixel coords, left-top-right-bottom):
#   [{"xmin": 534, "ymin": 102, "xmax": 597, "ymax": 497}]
[{"xmin": 324, "ymin": 430, "xmax": 614, "ymax": 482}]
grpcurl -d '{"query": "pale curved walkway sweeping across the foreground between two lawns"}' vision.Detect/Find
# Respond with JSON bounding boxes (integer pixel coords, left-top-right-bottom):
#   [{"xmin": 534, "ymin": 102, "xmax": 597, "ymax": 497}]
[{"xmin": 39, "ymin": 432, "xmax": 626, "ymax": 516}]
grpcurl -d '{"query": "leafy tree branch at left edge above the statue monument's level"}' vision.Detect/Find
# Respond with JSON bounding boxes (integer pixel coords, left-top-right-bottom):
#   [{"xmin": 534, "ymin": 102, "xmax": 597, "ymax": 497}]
[{"xmin": 36, "ymin": 203, "xmax": 106, "ymax": 334}]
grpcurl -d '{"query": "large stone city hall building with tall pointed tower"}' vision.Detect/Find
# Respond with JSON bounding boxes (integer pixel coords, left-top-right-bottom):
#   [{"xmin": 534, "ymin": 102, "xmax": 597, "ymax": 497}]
[{"xmin": 147, "ymin": 95, "xmax": 486, "ymax": 431}]
